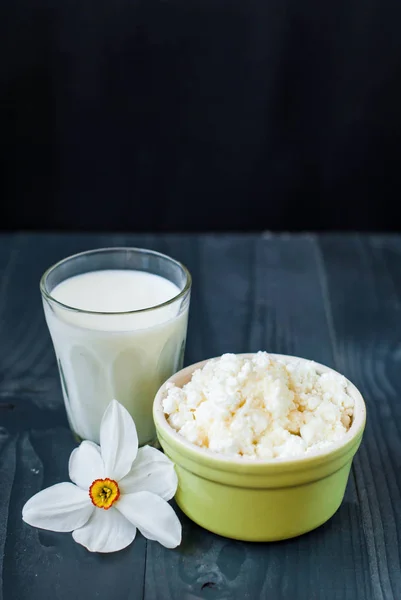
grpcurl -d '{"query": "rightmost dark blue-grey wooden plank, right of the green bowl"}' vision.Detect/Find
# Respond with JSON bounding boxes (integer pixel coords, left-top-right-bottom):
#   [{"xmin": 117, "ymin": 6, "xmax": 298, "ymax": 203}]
[{"xmin": 319, "ymin": 235, "xmax": 401, "ymax": 600}]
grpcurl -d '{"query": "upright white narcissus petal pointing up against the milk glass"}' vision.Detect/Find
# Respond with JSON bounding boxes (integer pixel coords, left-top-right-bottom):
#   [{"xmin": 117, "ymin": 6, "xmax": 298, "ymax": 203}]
[{"xmin": 100, "ymin": 400, "xmax": 138, "ymax": 481}]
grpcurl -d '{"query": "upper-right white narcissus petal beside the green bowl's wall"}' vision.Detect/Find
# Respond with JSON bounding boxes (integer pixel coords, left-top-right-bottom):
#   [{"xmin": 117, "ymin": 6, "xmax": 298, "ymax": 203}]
[{"xmin": 119, "ymin": 446, "xmax": 178, "ymax": 500}]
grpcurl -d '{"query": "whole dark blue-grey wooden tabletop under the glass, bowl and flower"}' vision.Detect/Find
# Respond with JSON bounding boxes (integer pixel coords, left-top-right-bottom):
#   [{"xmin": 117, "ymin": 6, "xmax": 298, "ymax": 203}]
[{"xmin": 0, "ymin": 234, "xmax": 401, "ymax": 600}]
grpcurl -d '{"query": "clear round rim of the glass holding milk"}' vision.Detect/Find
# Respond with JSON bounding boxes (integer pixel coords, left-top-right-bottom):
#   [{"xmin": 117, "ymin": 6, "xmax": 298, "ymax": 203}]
[{"xmin": 39, "ymin": 246, "xmax": 192, "ymax": 317}]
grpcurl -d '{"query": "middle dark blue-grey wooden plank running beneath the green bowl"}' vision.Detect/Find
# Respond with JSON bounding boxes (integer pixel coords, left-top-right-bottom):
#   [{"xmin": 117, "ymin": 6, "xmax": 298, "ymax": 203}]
[{"xmin": 145, "ymin": 236, "xmax": 373, "ymax": 600}]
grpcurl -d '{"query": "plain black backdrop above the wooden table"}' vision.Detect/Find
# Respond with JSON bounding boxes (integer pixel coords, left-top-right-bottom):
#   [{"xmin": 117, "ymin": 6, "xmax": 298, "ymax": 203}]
[{"xmin": 0, "ymin": 0, "xmax": 401, "ymax": 231}]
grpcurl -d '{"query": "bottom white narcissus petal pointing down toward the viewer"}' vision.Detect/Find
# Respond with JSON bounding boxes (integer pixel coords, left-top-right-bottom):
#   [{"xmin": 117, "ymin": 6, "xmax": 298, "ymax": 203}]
[{"xmin": 72, "ymin": 506, "xmax": 136, "ymax": 552}]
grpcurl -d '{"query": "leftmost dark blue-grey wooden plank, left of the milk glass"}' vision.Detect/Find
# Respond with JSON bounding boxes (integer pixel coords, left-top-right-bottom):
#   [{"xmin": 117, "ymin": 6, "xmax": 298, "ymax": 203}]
[{"xmin": 0, "ymin": 234, "xmax": 146, "ymax": 600}]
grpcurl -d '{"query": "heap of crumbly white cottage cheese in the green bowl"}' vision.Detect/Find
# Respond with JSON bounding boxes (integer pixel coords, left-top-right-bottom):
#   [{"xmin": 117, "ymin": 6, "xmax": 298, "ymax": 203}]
[{"xmin": 163, "ymin": 352, "xmax": 354, "ymax": 459}]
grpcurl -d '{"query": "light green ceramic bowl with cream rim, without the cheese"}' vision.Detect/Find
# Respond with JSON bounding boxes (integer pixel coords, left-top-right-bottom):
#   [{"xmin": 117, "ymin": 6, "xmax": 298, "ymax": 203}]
[{"xmin": 153, "ymin": 355, "xmax": 366, "ymax": 542}]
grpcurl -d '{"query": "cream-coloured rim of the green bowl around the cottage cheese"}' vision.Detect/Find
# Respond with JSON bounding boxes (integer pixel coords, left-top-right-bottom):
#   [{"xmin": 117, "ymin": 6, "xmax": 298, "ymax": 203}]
[{"xmin": 153, "ymin": 352, "xmax": 366, "ymax": 470}]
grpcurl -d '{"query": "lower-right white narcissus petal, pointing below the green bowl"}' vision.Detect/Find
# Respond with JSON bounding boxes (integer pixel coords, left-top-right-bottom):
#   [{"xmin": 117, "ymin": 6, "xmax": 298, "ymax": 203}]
[{"xmin": 115, "ymin": 492, "xmax": 181, "ymax": 548}]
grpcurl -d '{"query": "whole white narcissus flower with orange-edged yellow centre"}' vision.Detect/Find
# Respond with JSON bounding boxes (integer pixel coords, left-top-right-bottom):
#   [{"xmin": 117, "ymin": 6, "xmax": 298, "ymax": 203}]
[{"xmin": 22, "ymin": 400, "xmax": 181, "ymax": 552}]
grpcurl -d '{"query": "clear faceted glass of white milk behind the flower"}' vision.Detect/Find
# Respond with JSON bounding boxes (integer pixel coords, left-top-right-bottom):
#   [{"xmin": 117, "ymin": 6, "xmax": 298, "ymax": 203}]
[{"xmin": 40, "ymin": 248, "xmax": 191, "ymax": 445}]
